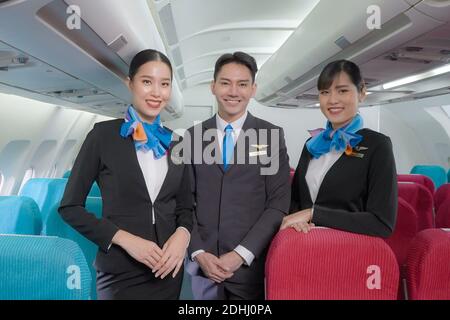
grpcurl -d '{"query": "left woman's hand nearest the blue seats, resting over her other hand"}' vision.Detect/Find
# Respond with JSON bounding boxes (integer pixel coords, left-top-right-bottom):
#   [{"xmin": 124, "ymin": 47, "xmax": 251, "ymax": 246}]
[{"xmin": 112, "ymin": 230, "xmax": 163, "ymax": 269}]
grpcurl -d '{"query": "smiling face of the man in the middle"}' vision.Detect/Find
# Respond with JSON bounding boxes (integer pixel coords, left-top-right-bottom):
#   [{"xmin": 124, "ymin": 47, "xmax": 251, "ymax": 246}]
[{"xmin": 211, "ymin": 62, "xmax": 256, "ymax": 123}]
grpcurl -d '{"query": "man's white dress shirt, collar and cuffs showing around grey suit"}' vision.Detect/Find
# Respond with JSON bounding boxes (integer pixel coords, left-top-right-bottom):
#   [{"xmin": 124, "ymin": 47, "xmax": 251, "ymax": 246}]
[{"xmin": 191, "ymin": 111, "xmax": 255, "ymax": 266}]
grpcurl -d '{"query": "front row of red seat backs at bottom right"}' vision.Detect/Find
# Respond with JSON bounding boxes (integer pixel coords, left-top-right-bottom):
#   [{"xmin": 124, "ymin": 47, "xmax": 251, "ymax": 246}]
[{"xmin": 266, "ymin": 228, "xmax": 450, "ymax": 300}]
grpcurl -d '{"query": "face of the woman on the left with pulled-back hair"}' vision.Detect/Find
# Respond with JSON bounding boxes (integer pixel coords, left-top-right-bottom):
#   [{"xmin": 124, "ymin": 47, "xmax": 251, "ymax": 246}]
[{"xmin": 128, "ymin": 61, "xmax": 172, "ymax": 123}]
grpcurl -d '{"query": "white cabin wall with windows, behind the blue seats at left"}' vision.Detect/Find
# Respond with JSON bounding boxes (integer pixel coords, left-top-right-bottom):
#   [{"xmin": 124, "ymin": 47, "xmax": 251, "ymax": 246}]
[{"xmin": 0, "ymin": 93, "xmax": 109, "ymax": 195}]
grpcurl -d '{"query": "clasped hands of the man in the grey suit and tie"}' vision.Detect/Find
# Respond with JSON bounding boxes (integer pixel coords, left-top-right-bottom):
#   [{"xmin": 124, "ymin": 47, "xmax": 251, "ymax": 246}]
[{"xmin": 195, "ymin": 251, "xmax": 244, "ymax": 283}]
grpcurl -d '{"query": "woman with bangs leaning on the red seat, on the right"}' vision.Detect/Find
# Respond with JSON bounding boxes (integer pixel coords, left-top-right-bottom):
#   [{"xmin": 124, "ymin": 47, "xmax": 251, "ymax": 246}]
[{"xmin": 281, "ymin": 60, "xmax": 397, "ymax": 237}]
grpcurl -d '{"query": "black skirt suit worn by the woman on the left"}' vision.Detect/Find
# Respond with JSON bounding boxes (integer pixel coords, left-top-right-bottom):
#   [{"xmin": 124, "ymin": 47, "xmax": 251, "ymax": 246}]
[{"xmin": 58, "ymin": 119, "xmax": 193, "ymax": 299}]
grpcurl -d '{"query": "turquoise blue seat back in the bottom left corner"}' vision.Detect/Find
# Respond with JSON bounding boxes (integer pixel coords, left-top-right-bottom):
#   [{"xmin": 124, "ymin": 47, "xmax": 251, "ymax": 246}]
[{"xmin": 0, "ymin": 234, "xmax": 93, "ymax": 300}]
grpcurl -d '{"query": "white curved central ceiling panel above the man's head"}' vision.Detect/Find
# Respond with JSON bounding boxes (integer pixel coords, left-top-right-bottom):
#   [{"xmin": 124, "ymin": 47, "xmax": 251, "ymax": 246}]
[{"xmin": 149, "ymin": 0, "xmax": 319, "ymax": 89}]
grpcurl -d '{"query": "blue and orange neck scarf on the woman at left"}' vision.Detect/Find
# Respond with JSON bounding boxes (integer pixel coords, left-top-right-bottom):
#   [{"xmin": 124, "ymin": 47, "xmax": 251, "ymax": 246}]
[{"xmin": 120, "ymin": 105, "xmax": 172, "ymax": 159}]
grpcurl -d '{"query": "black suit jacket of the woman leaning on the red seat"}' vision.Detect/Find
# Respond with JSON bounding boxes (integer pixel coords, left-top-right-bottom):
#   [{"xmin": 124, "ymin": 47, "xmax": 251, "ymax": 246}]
[{"xmin": 290, "ymin": 128, "xmax": 397, "ymax": 238}]
